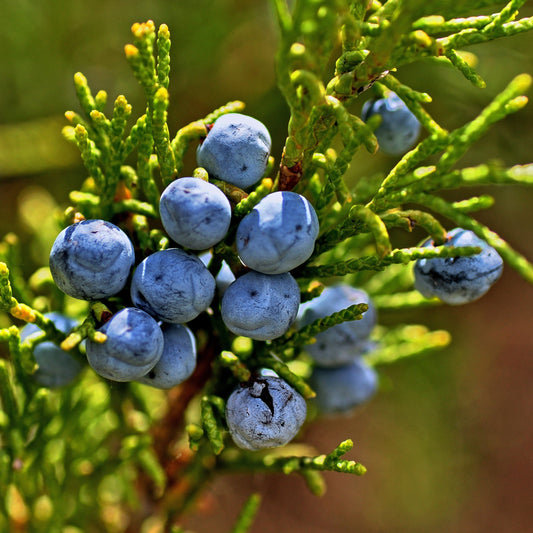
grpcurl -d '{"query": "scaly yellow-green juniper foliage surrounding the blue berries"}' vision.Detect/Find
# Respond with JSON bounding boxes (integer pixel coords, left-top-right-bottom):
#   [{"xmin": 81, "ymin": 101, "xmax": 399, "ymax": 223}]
[{"xmin": 0, "ymin": 0, "xmax": 533, "ymax": 532}]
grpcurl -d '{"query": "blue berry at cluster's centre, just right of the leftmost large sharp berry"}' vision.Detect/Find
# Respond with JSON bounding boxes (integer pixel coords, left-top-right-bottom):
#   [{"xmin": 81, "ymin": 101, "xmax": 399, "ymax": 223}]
[{"xmin": 131, "ymin": 248, "xmax": 215, "ymax": 324}]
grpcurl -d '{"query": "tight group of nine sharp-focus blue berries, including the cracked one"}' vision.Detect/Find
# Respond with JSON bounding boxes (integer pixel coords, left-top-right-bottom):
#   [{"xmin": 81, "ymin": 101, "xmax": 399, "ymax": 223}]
[{"xmin": 38, "ymin": 113, "xmax": 319, "ymax": 449}]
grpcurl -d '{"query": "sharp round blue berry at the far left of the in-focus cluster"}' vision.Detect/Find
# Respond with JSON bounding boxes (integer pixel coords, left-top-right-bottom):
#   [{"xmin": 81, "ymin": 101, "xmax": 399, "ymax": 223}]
[{"xmin": 50, "ymin": 220, "xmax": 135, "ymax": 300}]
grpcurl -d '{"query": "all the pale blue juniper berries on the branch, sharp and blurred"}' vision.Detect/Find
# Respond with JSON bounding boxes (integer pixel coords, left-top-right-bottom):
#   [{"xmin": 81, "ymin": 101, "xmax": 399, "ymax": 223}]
[{"xmin": 29, "ymin": 107, "xmax": 502, "ymax": 450}]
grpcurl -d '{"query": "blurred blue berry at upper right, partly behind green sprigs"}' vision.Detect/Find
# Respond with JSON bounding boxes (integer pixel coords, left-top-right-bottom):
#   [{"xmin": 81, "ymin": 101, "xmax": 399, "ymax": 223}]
[{"xmin": 361, "ymin": 93, "xmax": 421, "ymax": 155}]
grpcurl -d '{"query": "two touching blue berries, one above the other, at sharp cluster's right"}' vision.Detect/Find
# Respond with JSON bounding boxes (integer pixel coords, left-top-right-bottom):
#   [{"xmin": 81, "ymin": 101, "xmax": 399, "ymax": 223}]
[{"xmin": 221, "ymin": 191, "xmax": 318, "ymax": 340}]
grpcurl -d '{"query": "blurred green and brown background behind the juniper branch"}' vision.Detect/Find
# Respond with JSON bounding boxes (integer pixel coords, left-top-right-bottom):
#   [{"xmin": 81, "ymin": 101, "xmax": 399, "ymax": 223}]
[{"xmin": 0, "ymin": 0, "xmax": 533, "ymax": 533}]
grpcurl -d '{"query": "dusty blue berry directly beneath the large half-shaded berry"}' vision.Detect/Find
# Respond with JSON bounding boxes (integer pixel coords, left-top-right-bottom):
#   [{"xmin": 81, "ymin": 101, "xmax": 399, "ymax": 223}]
[{"xmin": 221, "ymin": 271, "xmax": 300, "ymax": 340}]
